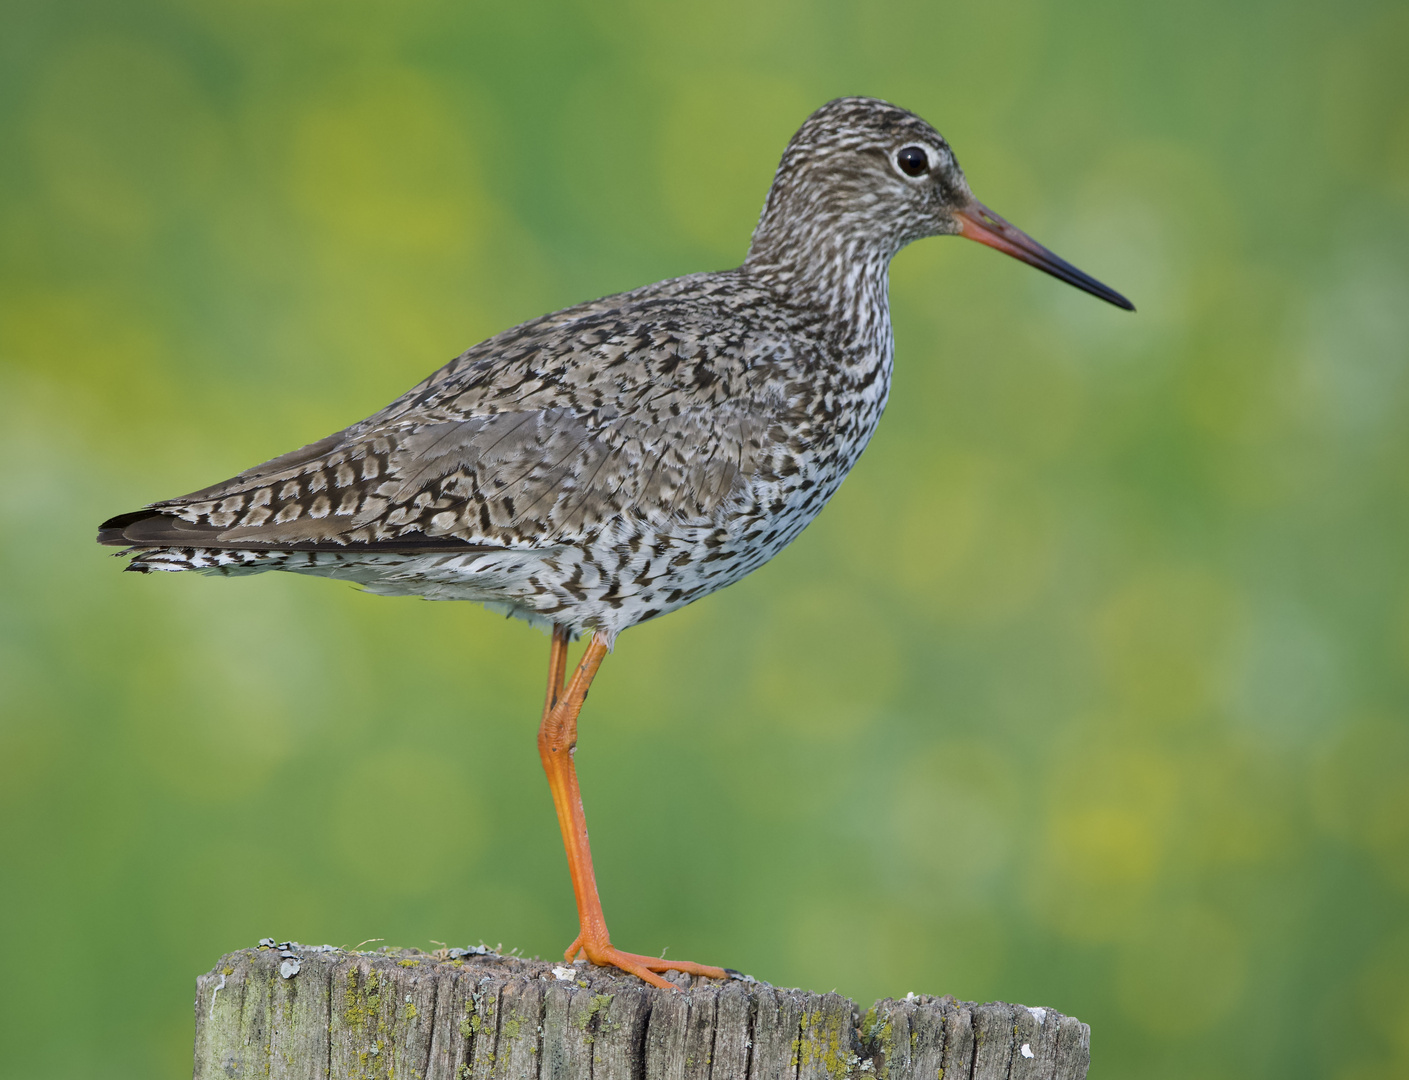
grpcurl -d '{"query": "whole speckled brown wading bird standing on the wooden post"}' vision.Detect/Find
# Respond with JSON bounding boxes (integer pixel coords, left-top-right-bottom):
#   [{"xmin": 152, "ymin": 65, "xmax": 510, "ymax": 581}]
[{"xmin": 97, "ymin": 97, "xmax": 1134, "ymax": 988}]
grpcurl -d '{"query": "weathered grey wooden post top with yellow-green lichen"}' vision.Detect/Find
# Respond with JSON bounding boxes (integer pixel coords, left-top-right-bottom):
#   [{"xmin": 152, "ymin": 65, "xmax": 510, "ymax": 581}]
[{"xmin": 196, "ymin": 941, "xmax": 1091, "ymax": 1080}]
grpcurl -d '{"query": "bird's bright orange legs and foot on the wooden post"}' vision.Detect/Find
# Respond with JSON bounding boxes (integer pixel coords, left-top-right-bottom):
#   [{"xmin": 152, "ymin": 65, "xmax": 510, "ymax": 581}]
[{"xmin": 538, "ymin": 627, "xmax": 728, "ymax": 990}]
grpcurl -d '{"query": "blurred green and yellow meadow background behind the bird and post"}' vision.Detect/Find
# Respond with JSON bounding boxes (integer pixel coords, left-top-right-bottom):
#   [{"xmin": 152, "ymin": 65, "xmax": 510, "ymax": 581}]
[{"xmin": 0, "ymin": 0, "xmax": 1409, "ymax": 1080}]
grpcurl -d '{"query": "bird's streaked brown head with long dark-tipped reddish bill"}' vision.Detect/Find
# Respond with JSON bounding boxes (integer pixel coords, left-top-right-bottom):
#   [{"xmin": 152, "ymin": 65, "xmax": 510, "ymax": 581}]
[{"xmin": 745, "ymin": 97, "xmax": 1134, "ymax": 311}]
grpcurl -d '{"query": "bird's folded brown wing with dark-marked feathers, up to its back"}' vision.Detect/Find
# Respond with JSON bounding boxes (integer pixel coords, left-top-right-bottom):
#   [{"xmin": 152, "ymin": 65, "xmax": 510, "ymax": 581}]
[{"xmin": 100, "ymin": 284, "xmax": 774, "ymax": 552}]
